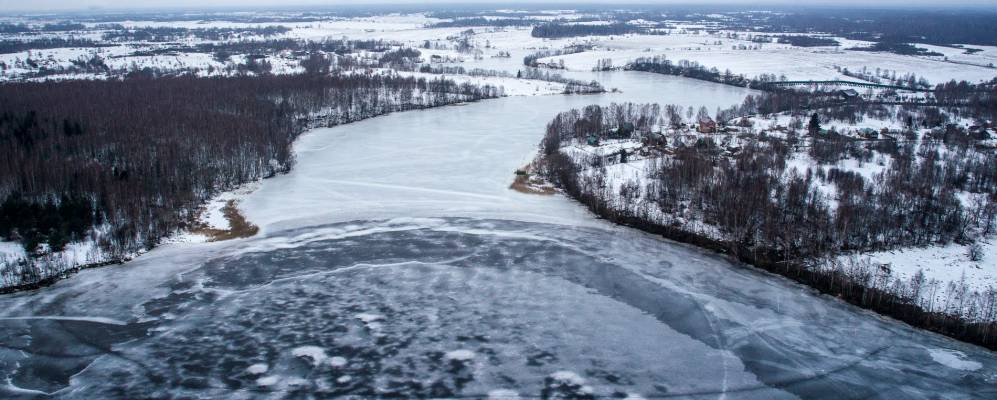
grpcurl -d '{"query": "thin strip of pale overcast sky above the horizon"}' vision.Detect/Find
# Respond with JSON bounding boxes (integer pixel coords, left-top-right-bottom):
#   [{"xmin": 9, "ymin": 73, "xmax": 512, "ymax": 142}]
[{"xmin": 0, "ymin": 0, "xmax": 997, "ymax": 12}]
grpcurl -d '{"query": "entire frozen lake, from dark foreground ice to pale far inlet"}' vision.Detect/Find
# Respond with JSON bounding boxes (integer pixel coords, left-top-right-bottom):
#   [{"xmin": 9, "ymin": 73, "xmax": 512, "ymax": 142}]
[{"xmin": 0, "ymin": 72, "xmax": 997, "ymax": 399}]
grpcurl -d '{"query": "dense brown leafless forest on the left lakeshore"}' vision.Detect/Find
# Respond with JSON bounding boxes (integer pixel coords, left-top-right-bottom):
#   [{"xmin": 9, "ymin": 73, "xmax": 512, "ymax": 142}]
[{"xmin": 0, "ymin": 74, "xmax": 498, "ymax": 282}]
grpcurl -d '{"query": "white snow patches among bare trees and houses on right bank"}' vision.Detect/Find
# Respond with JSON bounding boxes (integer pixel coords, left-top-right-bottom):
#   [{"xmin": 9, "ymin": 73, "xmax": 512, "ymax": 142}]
[{"xmin": 561, "ymin": 108, "xmax": 997, "ymax": 305}]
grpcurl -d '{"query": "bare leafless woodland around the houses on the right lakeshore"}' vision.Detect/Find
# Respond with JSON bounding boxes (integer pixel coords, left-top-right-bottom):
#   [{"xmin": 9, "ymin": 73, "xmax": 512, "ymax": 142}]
[{"xmin": 538, "ymin": 101, "xmax": 997, "ymax": 348}]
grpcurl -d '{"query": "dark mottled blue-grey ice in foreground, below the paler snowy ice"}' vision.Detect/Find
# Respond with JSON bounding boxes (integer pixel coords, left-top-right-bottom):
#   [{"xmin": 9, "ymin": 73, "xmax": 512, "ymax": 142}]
[{"xmin": 0, "ymin": 218, "xmax": 997, "ymax": 399}]
